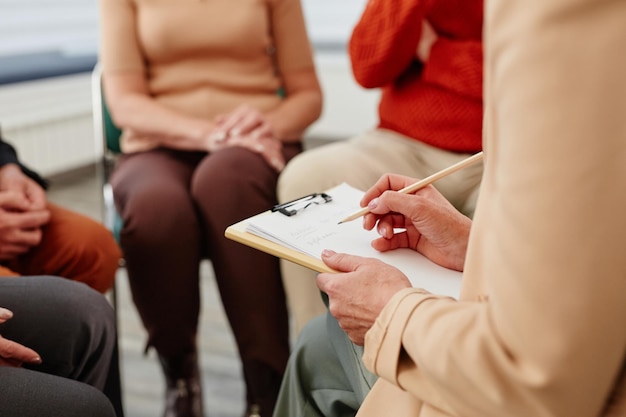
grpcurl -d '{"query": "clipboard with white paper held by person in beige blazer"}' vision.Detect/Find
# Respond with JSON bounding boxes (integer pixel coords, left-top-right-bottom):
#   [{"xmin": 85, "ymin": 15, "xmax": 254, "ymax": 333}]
[{"xmin": 225, "ymin": 184, "xmax": 462, "ymax": 298}]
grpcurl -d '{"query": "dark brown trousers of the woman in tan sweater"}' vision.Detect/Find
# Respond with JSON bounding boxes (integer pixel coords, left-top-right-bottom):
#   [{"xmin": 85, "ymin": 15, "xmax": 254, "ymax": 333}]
[{"xmin": 111, "ymin": 144, "xmax": 301, "ymax": 409}]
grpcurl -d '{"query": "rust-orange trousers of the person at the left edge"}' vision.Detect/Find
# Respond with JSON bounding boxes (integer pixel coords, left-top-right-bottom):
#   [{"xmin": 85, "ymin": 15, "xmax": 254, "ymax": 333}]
[{"xmin": 0, "ymin": 203, "xmax": 121, "ymax": 293}]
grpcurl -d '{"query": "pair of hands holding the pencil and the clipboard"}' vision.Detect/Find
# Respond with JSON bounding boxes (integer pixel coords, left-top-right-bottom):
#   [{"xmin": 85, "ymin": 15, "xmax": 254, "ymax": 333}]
[{"xmin": 317, "ymin": 174, "xmax": 471, "ymax": 345}]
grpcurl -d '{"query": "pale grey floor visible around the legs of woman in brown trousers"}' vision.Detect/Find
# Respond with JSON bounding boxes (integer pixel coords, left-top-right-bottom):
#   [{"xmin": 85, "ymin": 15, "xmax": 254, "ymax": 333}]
[{"xmin": 48, "ymin": 169, "xmax": 244, "ymax": 417}]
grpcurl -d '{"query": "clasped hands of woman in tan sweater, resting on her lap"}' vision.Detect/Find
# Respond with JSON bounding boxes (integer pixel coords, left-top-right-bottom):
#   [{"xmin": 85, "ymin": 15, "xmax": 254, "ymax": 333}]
[{"xmin": 206, "ymin": 105, "xmax": 285, "ymax": 172}]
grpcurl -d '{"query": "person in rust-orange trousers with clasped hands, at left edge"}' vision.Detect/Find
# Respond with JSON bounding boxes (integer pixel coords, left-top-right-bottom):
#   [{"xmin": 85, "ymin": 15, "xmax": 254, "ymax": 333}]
[{"xmin": 0, "ymin": 134, "xmax": 121, "ymax": 293}]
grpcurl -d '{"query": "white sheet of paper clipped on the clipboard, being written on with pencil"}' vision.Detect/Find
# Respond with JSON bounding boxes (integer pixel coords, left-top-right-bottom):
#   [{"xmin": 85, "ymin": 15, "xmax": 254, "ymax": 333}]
[{"xmin": 247, "ymin": 183, "xmax": 462, "ymax": 298}]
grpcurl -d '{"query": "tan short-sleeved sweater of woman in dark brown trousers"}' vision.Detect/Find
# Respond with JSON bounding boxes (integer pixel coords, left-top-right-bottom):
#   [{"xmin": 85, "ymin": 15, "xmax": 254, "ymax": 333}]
[{"xmin": 100, "ymin": 0, "xmax": 314, "ymax": 152}]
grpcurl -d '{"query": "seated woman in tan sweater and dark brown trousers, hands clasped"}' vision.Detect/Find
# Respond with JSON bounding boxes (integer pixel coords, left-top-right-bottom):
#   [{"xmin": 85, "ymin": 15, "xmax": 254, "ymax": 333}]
[{"xmin": 100, "ymin": 0, "xmax": 322, "ymax": 417}]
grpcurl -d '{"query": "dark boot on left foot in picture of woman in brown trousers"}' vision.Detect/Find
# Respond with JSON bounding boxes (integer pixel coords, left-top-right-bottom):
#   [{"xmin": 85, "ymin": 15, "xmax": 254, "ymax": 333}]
[{"xmin": 159, "ymin": 351, "xmax": 203, "ymax": 417}]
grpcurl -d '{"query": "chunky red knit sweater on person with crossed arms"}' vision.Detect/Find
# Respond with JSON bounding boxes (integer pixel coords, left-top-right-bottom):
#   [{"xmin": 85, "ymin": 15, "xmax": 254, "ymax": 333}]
[{"xmin": 350, "ymin": 0, "xmax": 483, "ymax": 153}]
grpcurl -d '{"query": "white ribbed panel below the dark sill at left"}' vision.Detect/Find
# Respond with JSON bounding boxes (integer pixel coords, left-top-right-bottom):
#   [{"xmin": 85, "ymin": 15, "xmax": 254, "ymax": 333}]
[{"xmin": 0, "ymin": 74, "xmax": 95, "ymax": 176}]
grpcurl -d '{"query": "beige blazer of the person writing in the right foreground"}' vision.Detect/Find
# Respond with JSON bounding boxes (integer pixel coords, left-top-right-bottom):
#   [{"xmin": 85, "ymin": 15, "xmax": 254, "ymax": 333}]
[{"xmin": 358, "ymin": 0, "xmax": 626, "ymax": 417}]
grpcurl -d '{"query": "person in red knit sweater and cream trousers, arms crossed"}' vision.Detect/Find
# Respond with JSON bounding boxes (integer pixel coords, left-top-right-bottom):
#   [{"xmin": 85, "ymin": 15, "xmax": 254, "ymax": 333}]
[{"xmin": 278, "ymin": 0, "xmax": 483, "ymax": 333}]
